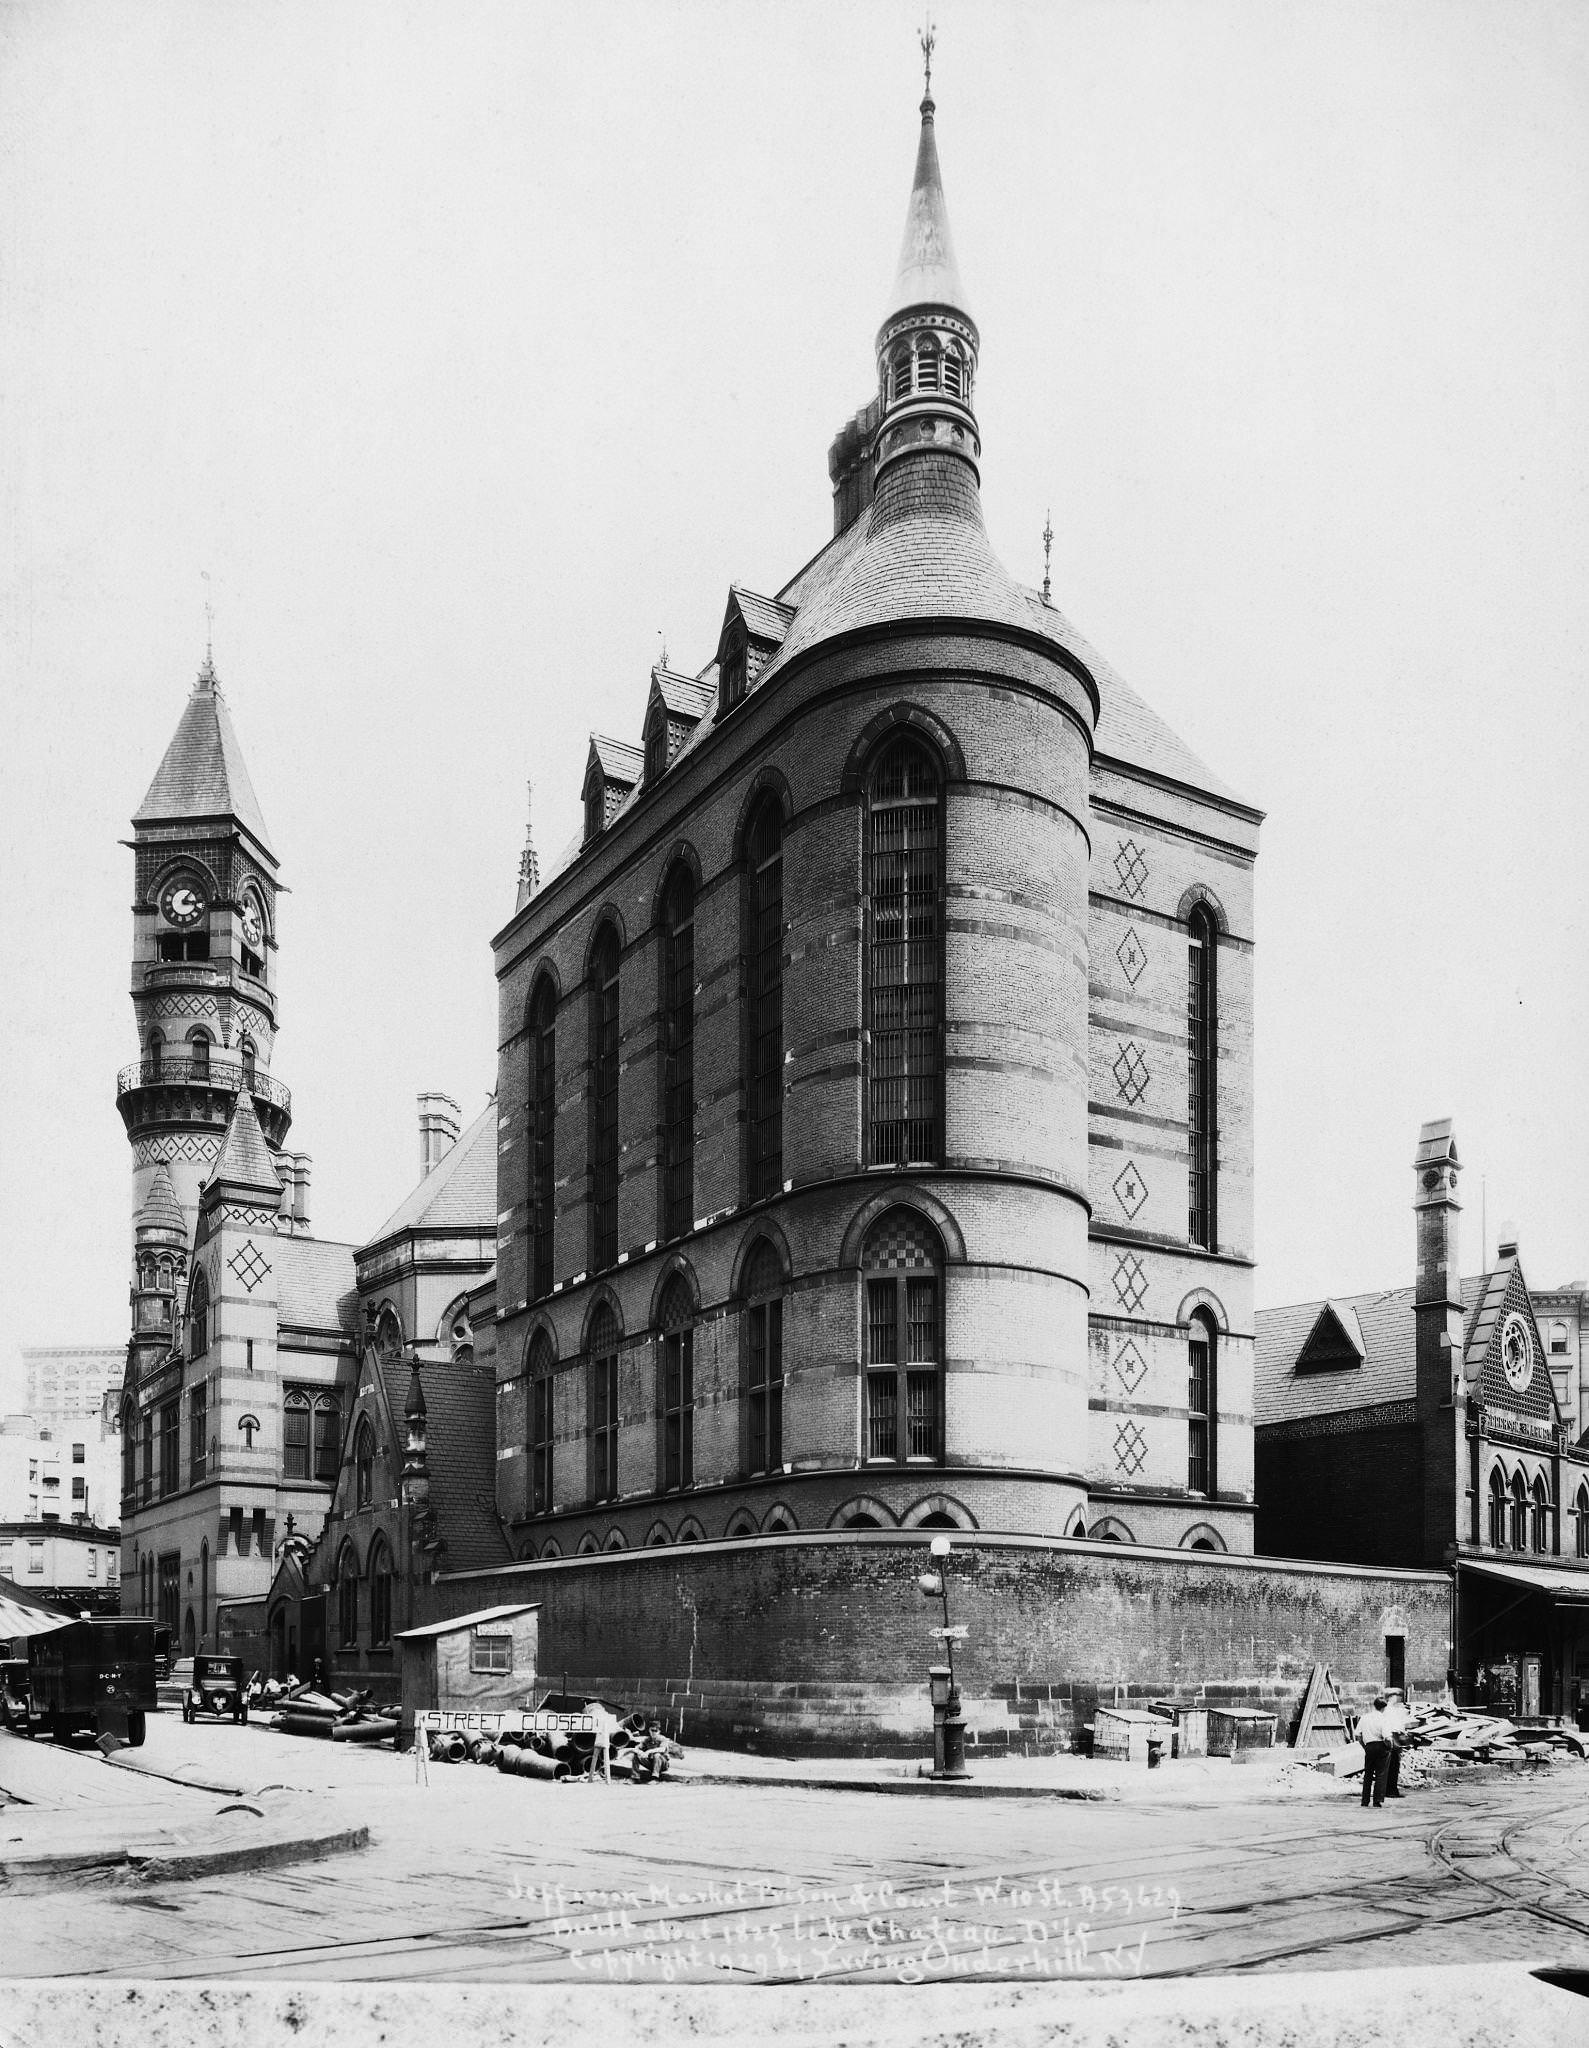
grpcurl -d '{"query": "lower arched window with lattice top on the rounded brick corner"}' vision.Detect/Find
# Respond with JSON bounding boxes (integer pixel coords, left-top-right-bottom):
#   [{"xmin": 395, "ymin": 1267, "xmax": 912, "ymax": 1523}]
[{"xmin": 862, "ymin": 1208, "xmax": 944, "ymax": 1464}]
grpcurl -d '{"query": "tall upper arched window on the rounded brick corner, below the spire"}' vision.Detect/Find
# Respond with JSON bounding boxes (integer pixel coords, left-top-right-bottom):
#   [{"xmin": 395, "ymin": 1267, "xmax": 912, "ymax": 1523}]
[{"xmin": 866, "ymin": 735, "xmax": 944, "ymax": 1165}]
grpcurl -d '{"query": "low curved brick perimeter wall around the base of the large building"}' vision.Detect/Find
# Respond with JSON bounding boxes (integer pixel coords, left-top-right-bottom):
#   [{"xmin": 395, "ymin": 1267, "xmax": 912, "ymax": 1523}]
[{"xmin": 430, "ymin": 1532, "xmax": 1450, "ymax": 1753}]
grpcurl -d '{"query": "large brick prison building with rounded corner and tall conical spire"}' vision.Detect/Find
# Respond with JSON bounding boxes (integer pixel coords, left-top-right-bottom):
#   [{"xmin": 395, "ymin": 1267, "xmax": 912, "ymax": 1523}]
[{"xmin": 496, "ymin": 72, "xmax": 1259, "ymax": 1556}]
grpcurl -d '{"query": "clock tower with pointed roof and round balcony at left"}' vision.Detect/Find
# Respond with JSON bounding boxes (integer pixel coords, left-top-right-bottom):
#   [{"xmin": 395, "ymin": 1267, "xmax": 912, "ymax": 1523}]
[{"xmin": 117, "ymin": 655, "xmax": 293, "ymax": 1245}]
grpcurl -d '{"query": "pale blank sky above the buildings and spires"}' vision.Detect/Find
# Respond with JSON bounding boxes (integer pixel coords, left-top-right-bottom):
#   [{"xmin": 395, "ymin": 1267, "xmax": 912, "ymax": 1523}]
[{"xmin": 0, "ymin": 0, "xmax": 1589, "ymax": 1407}]
